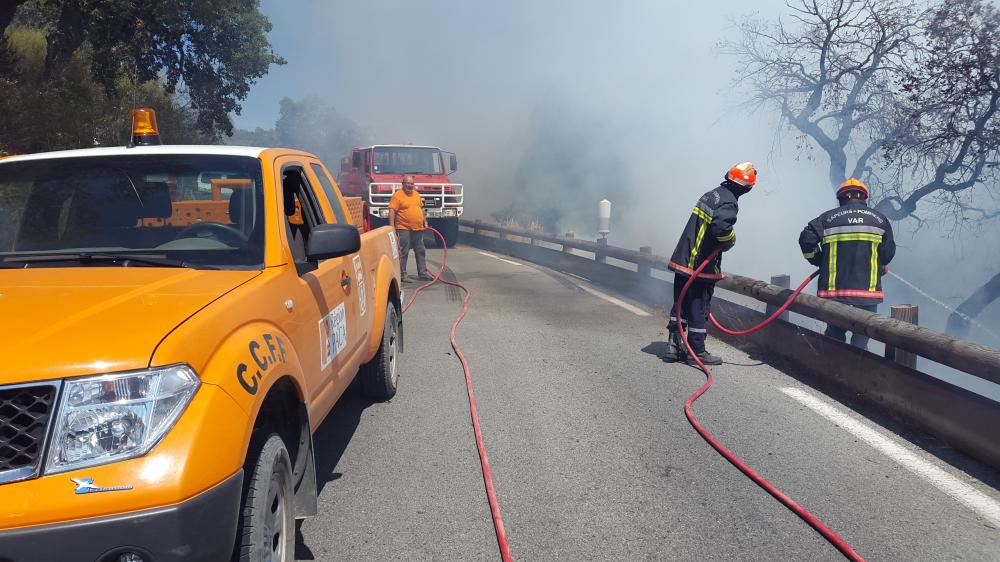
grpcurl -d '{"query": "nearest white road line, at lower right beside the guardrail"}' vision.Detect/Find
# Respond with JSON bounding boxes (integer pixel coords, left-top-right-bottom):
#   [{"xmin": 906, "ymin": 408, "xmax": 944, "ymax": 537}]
[{"xmin": 780, "ymin": 388, "xmax": 1000, "ymax": 528}]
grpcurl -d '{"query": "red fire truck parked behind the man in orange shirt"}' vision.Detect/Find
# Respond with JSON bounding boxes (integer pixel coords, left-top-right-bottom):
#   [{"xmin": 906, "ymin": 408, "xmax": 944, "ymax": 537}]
[{"xmin": 337, "ymin": 144, "xmax": 464, "ymax": 247}]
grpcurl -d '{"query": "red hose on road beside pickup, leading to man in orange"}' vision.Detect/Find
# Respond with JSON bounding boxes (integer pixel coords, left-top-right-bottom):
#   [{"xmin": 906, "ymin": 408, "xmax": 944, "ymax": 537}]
[{"xmin": 403, "ymin": 227, "xmax": 513, "ymax": 562}]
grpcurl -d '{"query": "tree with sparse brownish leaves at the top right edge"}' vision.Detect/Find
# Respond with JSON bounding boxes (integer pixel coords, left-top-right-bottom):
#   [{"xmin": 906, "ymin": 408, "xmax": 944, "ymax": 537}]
[{"xmin": 879, "ymin": 0, "xmax": 1000, "ymax": 224}]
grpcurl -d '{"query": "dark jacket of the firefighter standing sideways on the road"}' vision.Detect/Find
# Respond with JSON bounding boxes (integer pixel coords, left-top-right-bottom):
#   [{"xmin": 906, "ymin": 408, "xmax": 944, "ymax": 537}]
[{"xmin": 669, "ymin": 181, "xmax": 750, "ymax": 282}]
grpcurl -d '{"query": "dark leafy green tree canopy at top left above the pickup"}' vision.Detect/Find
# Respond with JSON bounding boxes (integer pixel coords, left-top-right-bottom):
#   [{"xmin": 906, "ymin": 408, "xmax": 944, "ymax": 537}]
[{"xmin": 0, "ymin": 0, "xmax": 284, "ymax": 136}]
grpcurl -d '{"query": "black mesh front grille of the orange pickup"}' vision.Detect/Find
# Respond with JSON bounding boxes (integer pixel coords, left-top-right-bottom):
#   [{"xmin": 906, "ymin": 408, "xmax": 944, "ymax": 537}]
[{"xmin": 0, "ymin": 384, "xmax": 56, "ymax": 483}]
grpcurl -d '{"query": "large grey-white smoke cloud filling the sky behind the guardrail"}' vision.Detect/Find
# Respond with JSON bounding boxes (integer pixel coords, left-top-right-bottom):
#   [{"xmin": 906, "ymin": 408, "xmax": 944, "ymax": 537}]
[{"xmin": 236, "ymin": 0, "xmax": 1000, "ymax": 345}]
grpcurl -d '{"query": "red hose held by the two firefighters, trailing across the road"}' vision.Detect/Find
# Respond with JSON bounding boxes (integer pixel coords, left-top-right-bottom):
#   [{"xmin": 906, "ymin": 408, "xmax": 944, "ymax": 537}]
[{"xmin": 677, "ymin": 249, "xmax": 864, "ymax": 562}]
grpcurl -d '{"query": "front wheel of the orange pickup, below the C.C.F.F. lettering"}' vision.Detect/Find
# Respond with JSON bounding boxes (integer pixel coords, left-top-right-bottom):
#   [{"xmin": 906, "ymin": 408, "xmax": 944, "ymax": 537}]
[{"xmin": 236, "ymin": 433, "xmax": 295, "ymax": 562}]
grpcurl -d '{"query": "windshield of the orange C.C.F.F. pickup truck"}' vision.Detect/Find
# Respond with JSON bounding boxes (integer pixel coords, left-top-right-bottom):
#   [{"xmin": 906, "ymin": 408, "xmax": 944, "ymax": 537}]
[{"xmin": 0, "ymin": 155, "xmax": 264, "ymax": 269}]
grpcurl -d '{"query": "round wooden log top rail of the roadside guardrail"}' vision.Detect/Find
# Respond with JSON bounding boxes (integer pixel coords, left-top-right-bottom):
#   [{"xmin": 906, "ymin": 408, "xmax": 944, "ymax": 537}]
[{"xmin": 460, "ymin": 220, "xmax": 1000, "ymax": 384}]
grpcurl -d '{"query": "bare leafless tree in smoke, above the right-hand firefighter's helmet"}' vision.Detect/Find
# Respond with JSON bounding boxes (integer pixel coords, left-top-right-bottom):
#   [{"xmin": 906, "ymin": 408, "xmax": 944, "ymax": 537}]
[{"xmin": 722, "ymin": 0, "xmax": 920, "ymax": 189}]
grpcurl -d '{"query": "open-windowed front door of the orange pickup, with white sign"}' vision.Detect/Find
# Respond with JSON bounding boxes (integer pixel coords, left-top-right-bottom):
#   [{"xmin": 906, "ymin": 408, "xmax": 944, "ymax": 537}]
[{"xmin": 275, "ymin": 157, "xmax": 357, "ymax": 420}]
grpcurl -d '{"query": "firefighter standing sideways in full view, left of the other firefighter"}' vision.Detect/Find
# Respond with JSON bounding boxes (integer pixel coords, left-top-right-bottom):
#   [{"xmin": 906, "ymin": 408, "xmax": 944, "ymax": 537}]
[{"xmin": 664, "ymin": 162, "xmax": 757, "ymax": 365}]
